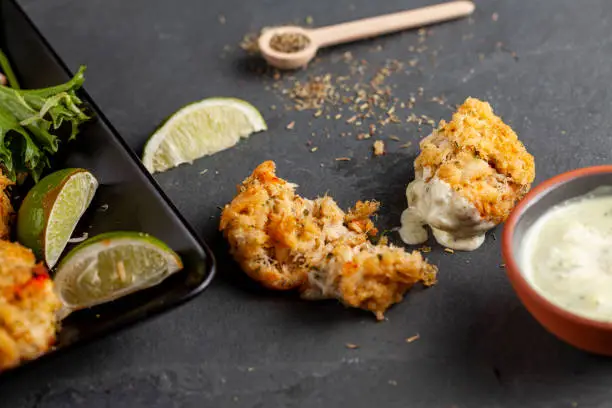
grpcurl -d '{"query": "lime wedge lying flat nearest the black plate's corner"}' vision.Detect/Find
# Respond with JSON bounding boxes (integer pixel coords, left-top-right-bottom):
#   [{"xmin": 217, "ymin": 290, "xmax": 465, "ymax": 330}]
[{"xmin": 53, "ymin": 231, "xmax": 183, "ymax": 316}]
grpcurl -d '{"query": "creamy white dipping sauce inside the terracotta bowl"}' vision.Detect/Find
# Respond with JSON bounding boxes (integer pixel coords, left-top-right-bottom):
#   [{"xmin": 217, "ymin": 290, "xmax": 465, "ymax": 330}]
[{"xmin": 519, "ymin": 187, "xmax": 612, "ymax": 321}]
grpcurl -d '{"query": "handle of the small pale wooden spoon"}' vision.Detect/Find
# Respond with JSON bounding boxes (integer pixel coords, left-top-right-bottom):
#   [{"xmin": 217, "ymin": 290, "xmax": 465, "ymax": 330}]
[{"xmin": 310, "ymin": 1, "xmax": 475, "ymax": 47}]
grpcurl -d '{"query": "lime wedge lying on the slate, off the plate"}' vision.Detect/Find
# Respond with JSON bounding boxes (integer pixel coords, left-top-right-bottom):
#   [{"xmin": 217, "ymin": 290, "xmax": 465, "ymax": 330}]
[{"xmin": 142, "ymin": 98, "xmax": 267, "ymax": 173}]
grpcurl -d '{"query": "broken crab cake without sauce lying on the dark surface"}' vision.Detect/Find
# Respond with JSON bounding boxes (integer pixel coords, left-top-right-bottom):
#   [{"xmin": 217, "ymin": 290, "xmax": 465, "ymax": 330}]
[{"xmin": 220, "ymin": 161, "xmax": 437, "ymax": 319}]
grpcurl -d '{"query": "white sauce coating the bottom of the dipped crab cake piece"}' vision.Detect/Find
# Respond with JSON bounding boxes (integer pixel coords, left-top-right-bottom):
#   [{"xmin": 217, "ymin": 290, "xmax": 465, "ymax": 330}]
[{"xmin": 399, "ymin": 169, "xmax": 495, "ymax": 251}]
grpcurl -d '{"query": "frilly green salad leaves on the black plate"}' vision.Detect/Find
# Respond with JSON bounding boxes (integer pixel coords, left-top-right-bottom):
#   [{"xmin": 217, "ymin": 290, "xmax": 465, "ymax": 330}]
[{"xmin": 0, "ymin": 52, "xmax": 89, "ymax": 181}]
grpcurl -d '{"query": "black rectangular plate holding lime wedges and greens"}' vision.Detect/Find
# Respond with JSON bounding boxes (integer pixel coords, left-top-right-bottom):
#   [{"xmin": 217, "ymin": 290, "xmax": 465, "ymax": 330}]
[{"xmin": 0, "ymin": 0, "xmax": 215, "ymax": 376}]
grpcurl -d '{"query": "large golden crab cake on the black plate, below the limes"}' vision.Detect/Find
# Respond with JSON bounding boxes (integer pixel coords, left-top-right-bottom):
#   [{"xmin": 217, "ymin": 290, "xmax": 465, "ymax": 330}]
[{"xmin": 0, "ymin": 241, "xmax": 61, "ymax": 371}]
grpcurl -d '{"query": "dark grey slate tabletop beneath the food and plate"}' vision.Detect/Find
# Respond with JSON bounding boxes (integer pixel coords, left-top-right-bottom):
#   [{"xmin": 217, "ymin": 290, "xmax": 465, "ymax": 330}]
[{"xmin": 0, "ymin": 0, "xmax": 612, "ymax": 408}]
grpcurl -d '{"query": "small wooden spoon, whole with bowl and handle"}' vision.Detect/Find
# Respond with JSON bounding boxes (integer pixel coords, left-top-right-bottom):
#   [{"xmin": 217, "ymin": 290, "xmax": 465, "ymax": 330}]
[{"xmin": 259, "ymin": 1, "xmax": 475, "ymax": 69}]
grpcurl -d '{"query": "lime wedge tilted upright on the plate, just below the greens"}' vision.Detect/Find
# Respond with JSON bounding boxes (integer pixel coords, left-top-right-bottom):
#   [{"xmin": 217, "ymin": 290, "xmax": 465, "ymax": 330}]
[{"xmin": 17, "ymin": 169, "xmax": 98, "ymax": 268}]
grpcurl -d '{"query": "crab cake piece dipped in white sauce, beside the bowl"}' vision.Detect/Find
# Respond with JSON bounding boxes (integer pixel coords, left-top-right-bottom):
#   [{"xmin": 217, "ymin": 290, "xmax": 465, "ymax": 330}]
[{"xmin": 401, "ymin": 98, "xmax": 535, "ymax": 250}]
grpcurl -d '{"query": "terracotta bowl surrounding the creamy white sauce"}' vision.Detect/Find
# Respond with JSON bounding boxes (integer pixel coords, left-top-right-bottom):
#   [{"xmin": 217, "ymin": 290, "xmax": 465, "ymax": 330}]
[{"xmin": 502, "ymin": 165, "xmax": 612, "ymax": 356}]
